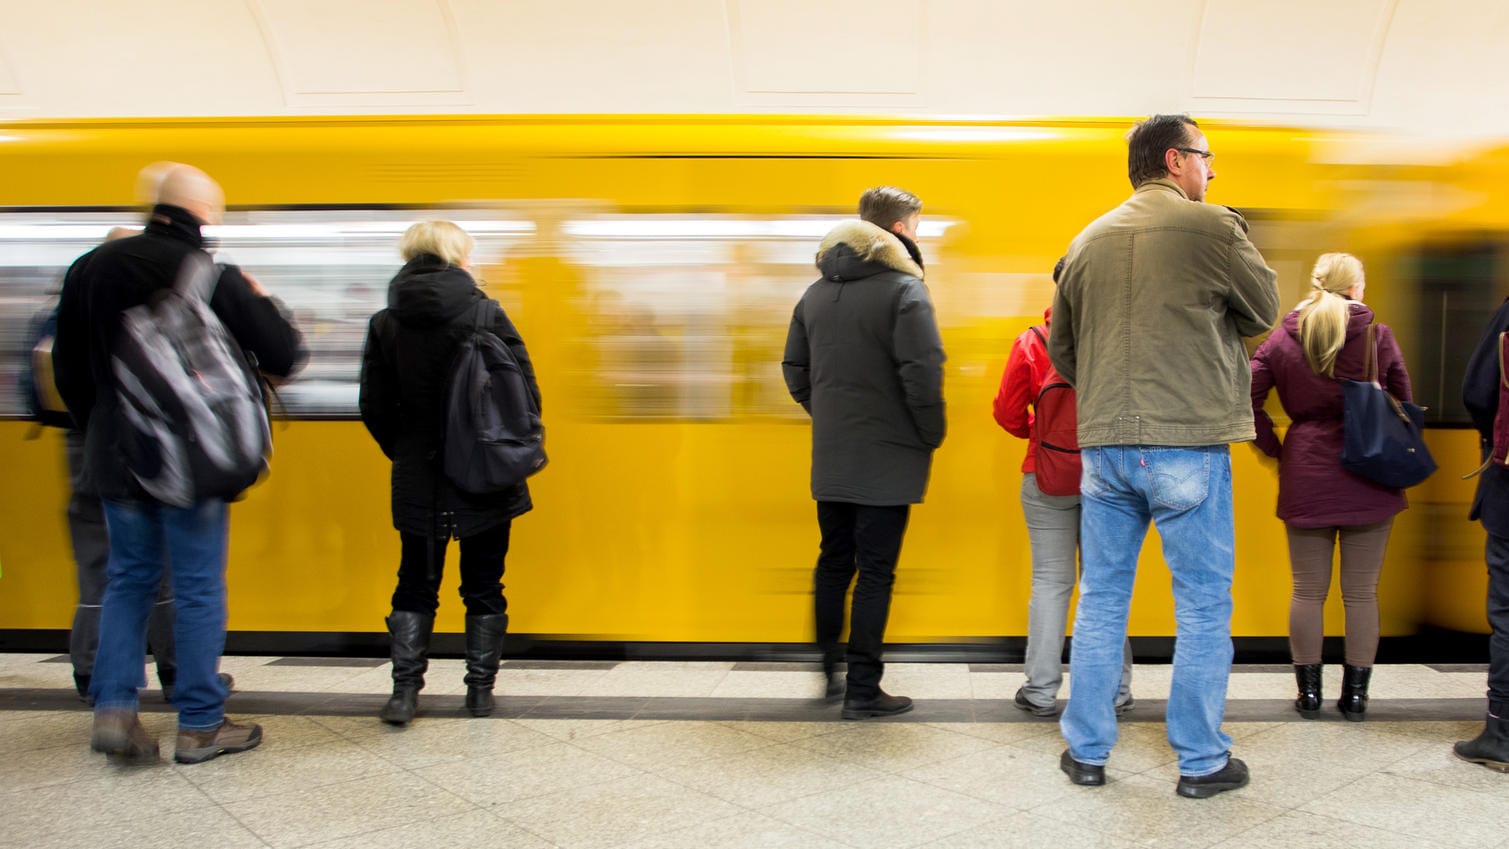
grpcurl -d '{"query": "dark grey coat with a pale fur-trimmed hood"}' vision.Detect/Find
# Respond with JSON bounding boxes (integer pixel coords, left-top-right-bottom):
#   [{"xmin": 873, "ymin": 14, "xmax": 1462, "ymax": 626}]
[{"xmin": 782, "ymin": 222, "xmax": 945, "ymax": 507}]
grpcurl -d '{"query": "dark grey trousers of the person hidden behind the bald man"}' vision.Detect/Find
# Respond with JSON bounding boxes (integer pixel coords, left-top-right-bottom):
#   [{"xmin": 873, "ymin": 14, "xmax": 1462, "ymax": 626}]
[{"xmin": 66, "ymin": 430, "xmax": 177, "ymax": 686}]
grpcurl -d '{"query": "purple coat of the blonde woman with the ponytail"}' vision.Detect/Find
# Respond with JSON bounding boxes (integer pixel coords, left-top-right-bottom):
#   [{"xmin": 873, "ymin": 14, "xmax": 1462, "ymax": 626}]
[{"xmin": 1252, "ymin": 302, "xmax": 1414, "ymax": 528}]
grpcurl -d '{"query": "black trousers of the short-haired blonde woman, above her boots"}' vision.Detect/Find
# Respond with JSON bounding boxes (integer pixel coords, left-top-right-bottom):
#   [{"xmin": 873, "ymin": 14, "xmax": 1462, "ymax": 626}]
[{"xmin": 392, "ymin": 522, "xmax": 513, "ymax": 617}]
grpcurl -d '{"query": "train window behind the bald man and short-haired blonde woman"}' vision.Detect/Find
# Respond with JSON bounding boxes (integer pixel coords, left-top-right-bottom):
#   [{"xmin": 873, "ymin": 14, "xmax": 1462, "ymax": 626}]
[{"xmin": 0, "ymin": 208, "xmax": 534, "ymax": 418}]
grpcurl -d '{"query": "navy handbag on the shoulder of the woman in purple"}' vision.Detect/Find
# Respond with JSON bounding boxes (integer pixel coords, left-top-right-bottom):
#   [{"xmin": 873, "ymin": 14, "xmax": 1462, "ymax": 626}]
[{"xmin": 1342, "ymin": 324, "xmax": 1435, "ymax": 489}]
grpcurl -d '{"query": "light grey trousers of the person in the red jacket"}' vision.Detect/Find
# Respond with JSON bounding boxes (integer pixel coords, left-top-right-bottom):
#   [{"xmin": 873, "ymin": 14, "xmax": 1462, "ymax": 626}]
[{"xmin": 1022, "ymin": 472, "xmax": 1132, "ymax": 707}]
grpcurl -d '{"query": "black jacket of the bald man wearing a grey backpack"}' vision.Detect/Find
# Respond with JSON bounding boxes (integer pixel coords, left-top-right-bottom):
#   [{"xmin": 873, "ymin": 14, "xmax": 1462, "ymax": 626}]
[{"xmin": 53, "ymin": 205, "xmax": 308, "ymax": 499}]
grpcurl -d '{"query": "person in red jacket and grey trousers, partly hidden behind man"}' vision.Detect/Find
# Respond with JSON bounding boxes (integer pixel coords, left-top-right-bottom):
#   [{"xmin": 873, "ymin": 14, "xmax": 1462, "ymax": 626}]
[{"xmin": 994, "ymin": 278, "xmax": 1135, "ymax": 716}]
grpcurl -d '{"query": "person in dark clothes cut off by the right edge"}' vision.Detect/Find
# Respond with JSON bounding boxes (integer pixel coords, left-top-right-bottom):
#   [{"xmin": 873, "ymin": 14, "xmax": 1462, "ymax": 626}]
[{"xmin": 1453, "ymin": 300, "xmax": 1509, "ymax": 772}]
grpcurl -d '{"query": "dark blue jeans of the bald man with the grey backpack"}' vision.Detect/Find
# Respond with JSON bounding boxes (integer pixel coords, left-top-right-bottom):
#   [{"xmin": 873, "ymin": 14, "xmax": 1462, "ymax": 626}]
[{"xmin": 89, "ymin": 501, "xmax": 229, "ymax": 731}]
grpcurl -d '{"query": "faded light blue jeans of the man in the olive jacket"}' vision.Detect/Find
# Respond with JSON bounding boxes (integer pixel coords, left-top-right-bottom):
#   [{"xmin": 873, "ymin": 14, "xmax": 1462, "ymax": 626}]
[{"xmin": 1059, "ymin": 445, "xmax": 1236, "ymax": 775}]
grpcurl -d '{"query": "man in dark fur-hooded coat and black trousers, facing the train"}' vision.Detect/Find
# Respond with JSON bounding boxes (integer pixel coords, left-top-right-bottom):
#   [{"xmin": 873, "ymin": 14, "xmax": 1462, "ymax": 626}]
[{"xmin": 782, "ymin": 185, "xmax": 945, "ymax": 719}]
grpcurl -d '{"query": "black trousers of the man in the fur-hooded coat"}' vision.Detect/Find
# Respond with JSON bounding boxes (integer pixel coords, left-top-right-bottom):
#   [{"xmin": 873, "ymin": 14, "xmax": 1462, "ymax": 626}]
[{"xmin": 812, "ymin": 501, "xmax": 911, "ymax": 700}]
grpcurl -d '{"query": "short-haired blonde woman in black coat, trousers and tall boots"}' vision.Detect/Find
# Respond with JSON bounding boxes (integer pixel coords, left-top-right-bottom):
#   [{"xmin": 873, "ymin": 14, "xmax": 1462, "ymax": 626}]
[{"xmin": 359, "ymin": 222, "xmax": 540, "ymax": 725}]
